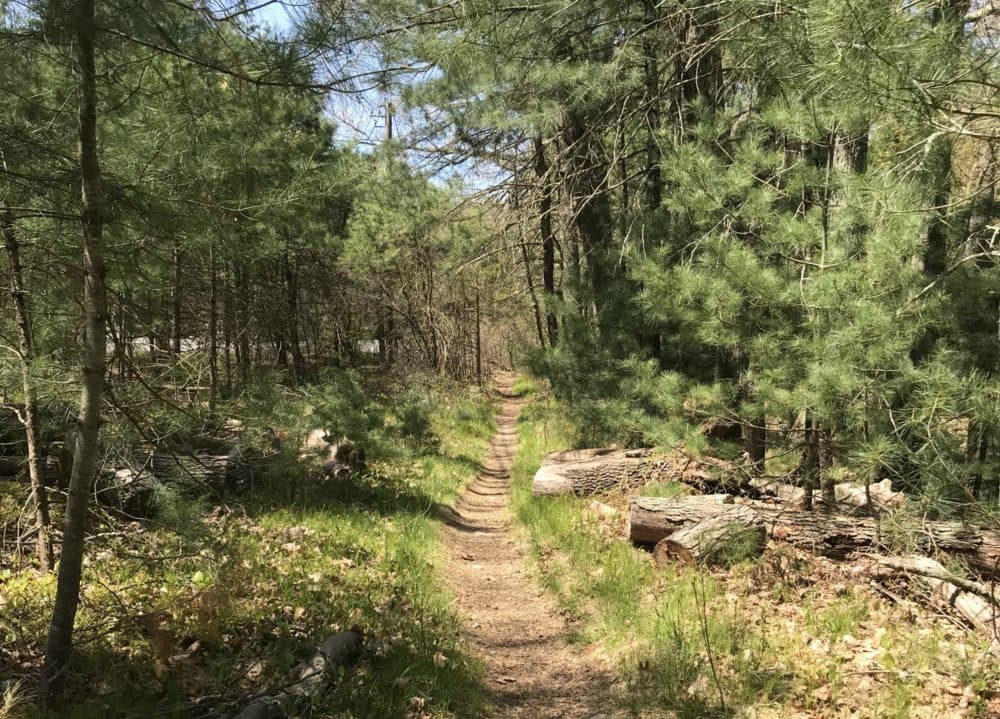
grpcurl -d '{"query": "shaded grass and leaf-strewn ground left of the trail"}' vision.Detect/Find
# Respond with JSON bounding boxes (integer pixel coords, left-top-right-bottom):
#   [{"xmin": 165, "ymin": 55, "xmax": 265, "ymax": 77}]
[{"xmin": 0, "ymin": 380, "xmax": 493, "ymax": 719}]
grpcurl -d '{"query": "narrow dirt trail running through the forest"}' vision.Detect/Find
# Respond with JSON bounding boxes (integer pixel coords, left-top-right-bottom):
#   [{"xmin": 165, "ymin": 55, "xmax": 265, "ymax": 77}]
[{"xmin": 444, "ymin": 379, "xmax": 613, "ymax": 719}]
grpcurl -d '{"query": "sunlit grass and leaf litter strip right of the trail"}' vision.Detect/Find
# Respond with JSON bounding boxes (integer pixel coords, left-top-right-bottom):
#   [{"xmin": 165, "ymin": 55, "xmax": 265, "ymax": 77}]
[{"xmin": 512, "ymin": 380, "xmax": 1000, "ymax": 719}]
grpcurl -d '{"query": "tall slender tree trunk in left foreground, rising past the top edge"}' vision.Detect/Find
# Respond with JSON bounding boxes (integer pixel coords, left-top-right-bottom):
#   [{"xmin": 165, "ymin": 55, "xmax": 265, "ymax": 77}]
[{"xmin": 45, "ymin": 0, "xmax": 107, "ymax": 678}]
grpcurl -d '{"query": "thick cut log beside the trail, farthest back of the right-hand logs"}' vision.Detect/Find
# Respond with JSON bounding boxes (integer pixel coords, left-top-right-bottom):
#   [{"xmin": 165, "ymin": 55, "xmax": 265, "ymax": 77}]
[{"xmin": 531, "ymin": 448, "xmax": 671, "ymax": 497}]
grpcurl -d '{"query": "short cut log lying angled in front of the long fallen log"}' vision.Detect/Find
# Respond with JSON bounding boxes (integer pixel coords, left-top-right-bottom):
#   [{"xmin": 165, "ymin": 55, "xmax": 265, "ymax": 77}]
[{"xmin": 653, "ymin": 504, "xmax": 765, "ymax": 568}]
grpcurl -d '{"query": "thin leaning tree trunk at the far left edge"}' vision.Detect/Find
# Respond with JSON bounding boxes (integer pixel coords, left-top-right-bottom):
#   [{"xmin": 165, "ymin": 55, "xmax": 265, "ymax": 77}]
[{"xmin": 0, "ymin": 203, "xmax": 53, "ymax": 572}]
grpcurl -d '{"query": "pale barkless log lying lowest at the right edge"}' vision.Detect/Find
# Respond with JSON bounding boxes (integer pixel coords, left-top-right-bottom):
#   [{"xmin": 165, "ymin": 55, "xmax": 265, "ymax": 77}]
[{"xmin": 875, "ymin": 556, "xmax": 1000, "ymax": 651}]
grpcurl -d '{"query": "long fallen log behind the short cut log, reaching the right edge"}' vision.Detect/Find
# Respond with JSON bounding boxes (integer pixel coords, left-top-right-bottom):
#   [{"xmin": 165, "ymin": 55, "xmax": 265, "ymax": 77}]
[{"xmin": 627, "ymin": 495, "xmax": 1000, "ymax": 576}]
